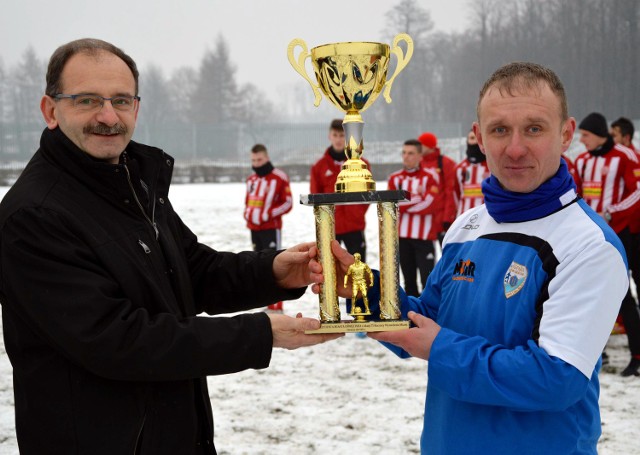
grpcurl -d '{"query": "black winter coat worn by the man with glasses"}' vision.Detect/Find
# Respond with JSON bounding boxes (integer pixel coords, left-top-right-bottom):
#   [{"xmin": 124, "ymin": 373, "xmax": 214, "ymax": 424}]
[{"xmin": 0, "ymin": 129, "xmax": 304, "ymax": 455}]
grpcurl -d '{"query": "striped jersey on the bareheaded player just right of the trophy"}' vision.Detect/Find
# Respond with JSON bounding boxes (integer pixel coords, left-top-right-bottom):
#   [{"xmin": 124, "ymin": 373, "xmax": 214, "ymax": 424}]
[{"xmin": 387, "ymin": 168, "xmax": 442, "ymax": 240}]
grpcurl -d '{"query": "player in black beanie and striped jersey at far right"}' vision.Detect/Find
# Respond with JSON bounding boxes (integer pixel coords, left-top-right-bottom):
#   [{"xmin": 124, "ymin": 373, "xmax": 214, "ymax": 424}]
[{"xmin": 575, "ymin": 112, "xmax": 640, "ymax": 376}]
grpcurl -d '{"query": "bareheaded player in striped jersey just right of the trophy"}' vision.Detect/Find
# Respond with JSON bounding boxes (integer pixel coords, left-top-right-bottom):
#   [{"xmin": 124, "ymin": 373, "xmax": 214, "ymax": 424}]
[{"xmin": 387, "ymin": 139, "xmax": 442, "ymax": 296}]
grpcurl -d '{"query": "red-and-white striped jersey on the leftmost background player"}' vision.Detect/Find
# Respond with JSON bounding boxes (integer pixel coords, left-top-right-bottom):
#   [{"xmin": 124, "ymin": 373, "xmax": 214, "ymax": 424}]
[{"xmin": 244, "ymin": 169, "xmax": 293, "ymax": 231}]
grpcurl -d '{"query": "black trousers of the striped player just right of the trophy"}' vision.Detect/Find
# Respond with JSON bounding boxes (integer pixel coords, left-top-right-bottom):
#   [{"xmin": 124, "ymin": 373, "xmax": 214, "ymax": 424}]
[{"xmin": 399, "ymin": 238, "xmax": 435, "ymax": 297}]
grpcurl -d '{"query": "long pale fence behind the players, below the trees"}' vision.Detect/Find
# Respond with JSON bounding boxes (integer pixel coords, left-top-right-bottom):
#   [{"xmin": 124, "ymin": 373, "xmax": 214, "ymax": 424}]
[{"xmin": 0, "ymin": 120, "xmax": 640, "ymax": 185}]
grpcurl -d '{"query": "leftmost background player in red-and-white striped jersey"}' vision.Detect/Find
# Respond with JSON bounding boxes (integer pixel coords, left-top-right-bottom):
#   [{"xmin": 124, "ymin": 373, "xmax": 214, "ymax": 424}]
[{"xmin": 244, "ymin": 144, "xmax": 293, "ymax": 311}]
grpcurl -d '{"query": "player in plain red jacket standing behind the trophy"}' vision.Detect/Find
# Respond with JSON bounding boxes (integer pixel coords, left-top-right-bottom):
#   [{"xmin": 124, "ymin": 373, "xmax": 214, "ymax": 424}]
[{"xmin": 310, "ymin": 119, "xmax": 371, "ymax": 262}]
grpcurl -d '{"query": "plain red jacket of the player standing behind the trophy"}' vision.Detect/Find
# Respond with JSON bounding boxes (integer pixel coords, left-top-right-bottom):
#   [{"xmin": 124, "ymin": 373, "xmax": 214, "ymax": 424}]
[{"xmin": 310, "ymin": 149, "xmax": 371, "ymax": 235}]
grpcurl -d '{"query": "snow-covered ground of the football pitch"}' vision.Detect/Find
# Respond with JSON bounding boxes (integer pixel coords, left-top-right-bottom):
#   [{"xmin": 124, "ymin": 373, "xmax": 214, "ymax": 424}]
[{"xmin": 0, "ymin": 182, "xmax": 640, "ymax": 455}]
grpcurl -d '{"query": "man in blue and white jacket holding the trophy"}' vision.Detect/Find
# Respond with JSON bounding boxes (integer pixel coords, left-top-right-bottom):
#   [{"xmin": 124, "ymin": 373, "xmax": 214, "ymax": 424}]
[{"xmin": 362, "ymin": 63, "xmax": 629, "ymax": 455}]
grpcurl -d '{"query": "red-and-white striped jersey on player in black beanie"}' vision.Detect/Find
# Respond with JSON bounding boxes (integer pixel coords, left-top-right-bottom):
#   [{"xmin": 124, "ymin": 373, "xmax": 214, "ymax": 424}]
[{"xmin": 575, "ymin": 144, "xmax": 640, "ymax": 233}]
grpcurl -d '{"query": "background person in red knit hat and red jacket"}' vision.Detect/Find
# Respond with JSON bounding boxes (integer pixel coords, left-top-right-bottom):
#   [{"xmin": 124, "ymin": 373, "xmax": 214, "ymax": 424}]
[{"xmin": 418, "ymin": 132, "xmax": 457, "ymax": 243}]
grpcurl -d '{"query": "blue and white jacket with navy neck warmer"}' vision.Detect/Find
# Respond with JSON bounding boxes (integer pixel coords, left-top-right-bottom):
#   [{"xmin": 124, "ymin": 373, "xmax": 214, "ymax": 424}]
[{"xmin": 382, "ymin": 163, "xmax": 629, "ymax": 455}]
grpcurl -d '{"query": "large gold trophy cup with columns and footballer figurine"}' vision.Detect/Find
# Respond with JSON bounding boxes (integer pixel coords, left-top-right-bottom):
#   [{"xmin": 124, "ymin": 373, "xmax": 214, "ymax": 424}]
[{"xmin": 287, "ymin": 33, "xmax": 413, "ymax": 333}]
